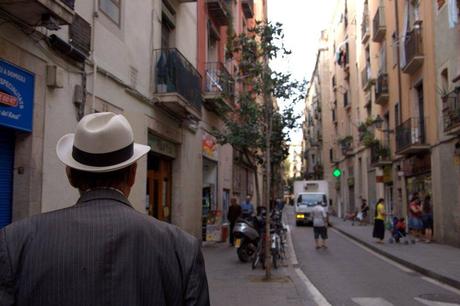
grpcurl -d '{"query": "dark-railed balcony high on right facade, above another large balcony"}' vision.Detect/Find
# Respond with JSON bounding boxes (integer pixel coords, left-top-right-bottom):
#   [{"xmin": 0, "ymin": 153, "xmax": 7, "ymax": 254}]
[{"xmin": 403, "ymin": 24, "xmax": 424, "ymax": 74}]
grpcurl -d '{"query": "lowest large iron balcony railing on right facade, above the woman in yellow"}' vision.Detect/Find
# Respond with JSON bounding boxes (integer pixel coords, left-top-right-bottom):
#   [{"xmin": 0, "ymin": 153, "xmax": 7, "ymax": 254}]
[{"xmin": 396, "ymin": 117, "xmax": 426, "ymax": 152}]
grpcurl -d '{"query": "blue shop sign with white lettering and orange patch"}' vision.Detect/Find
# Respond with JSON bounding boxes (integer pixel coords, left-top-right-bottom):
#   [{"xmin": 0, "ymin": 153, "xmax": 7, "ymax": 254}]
[{"xmin": 0, "ymin": 60, "xmax": 35, "ymax": 132}]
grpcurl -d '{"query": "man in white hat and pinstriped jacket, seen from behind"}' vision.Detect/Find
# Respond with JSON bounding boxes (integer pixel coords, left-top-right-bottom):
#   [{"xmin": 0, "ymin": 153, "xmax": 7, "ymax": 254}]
[{"xmin": 0, "ymin": 113, "xmax": 209, "ymax": 306}]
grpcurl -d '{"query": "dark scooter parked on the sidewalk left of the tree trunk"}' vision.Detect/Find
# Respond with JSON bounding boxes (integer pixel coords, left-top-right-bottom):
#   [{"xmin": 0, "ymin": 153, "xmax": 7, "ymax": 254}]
[{"xmin": 233, "ymin": 213, "xmax": 260, "ymax": 262}]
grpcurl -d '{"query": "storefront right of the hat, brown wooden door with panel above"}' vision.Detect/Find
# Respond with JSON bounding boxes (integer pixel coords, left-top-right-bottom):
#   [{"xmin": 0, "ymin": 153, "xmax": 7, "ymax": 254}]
[{"xmin": 145, "ymin": 134, "xmax": 177, "ymax": 222}]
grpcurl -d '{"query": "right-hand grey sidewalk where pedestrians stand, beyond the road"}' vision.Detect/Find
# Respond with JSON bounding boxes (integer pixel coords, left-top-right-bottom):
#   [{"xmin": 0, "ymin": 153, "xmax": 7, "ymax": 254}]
[{"xmin": 331, "ymin": 217, "xmax": 460, "ymax": 289}]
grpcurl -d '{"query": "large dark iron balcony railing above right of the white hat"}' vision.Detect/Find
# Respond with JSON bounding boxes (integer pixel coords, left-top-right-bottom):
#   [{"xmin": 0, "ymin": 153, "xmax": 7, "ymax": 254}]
[{"xmin": 154, "ymin": 48, "xmax": 202, "ymax": 111}]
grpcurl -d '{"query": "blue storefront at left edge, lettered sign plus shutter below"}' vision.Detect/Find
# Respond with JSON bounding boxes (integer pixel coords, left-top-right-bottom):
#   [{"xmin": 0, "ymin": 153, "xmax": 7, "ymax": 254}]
[{"xmin": 0, "ymin": 60, "xmax": 35, "ymax": 228}]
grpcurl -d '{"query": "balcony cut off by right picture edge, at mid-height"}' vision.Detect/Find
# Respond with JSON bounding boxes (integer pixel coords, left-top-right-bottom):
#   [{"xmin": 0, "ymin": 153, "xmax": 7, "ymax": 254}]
[{"xmin": 442, "ymin": 88, "xmax": 460, "ymax": 135}]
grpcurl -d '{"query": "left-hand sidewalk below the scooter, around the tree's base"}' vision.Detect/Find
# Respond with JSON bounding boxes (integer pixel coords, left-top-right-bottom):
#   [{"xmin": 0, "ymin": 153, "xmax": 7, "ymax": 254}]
[{"xmin": 203, "ymin": 243, "xmax": 313, "ymax": 306}]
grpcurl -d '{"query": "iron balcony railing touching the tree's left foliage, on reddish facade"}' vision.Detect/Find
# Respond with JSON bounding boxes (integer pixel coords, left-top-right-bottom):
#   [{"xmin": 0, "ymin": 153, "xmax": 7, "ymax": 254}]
[{"xmin": 204, "ymin": 62, "xmax": 235, "ymax": 102}]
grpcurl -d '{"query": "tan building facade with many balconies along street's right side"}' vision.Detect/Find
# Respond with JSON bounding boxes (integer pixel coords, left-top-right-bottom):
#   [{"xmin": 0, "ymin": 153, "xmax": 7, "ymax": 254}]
[{"xmin": 305, "ymin": 0, "xmax": 460, "ymax": 245}]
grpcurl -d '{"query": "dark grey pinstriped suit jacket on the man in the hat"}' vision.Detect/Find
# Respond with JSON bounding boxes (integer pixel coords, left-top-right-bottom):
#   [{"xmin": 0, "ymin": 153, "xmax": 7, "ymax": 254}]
[{"xmin": 0, "ymin": 189, "xmax": 209, "ymax": 306}]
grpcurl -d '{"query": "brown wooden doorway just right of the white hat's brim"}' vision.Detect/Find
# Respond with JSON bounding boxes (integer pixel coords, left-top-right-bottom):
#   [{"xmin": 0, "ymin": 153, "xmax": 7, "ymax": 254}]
[{"xmin": 146, "ymin": 152, "xmax": 172, "ymax": 222}]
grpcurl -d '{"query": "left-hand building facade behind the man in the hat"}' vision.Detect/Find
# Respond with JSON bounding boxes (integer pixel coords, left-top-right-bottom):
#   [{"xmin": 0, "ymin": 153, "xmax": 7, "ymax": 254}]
[{"xmin": 0, "ymin": 0, "xmax": 266, "ymax": 237}]
